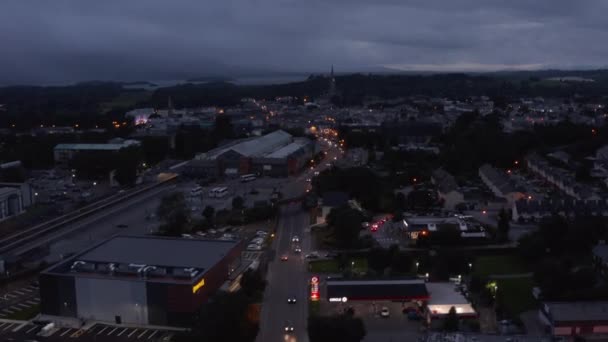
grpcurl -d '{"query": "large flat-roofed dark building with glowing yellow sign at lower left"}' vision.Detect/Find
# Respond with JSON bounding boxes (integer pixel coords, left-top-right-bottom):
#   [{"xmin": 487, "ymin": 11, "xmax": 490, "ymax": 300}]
[{"xmin": 40, "ymin": 236, "xmax": 242, "ymax": 326}]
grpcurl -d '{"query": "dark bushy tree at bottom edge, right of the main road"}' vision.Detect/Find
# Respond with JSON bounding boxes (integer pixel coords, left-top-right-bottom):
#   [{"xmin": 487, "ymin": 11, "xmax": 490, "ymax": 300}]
[{"xmin": 308, "ymin": 314, "xmax": 366, "ymax": 342}]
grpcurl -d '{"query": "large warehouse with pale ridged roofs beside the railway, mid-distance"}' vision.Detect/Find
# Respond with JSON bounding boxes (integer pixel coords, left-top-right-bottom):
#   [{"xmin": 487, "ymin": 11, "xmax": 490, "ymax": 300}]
[{"xmin": 185, "ymin": 130, "xmax": 316, "ymax": 177}]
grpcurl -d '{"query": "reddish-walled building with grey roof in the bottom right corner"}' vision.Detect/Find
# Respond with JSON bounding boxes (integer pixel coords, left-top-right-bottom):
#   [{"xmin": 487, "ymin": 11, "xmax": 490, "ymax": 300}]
[{"xmin": 539, "ymin": 301, "xmax": 608, "ymax": 337}]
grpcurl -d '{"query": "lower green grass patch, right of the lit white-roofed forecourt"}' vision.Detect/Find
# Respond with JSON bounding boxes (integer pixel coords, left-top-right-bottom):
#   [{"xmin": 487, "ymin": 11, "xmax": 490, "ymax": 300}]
[{"xmin": 497, "ymin": 277, "xmax": 538, "ymax": 317}]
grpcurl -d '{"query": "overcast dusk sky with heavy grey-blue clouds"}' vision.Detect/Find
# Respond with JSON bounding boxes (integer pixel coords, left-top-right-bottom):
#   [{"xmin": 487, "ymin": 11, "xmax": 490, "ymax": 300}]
[{"xmin": 0, "ymin": 0, "xmax": 608, "ymax": 84}]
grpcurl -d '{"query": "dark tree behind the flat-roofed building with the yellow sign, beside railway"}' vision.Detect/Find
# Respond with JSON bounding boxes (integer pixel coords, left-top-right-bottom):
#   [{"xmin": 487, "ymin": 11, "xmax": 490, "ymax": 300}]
[{"xmin": 156, "ymin": 192, "xmax": 190, "ymax": 236}]
